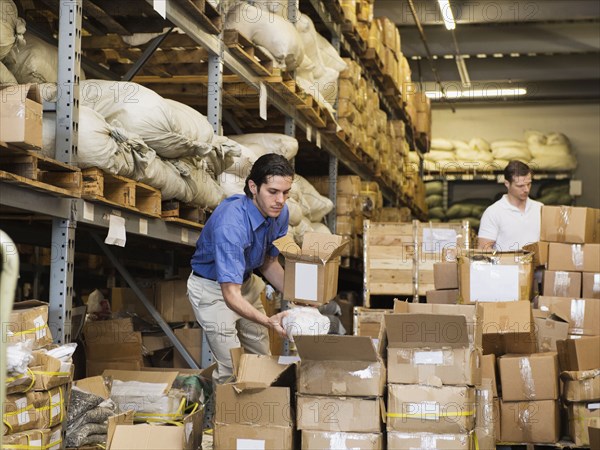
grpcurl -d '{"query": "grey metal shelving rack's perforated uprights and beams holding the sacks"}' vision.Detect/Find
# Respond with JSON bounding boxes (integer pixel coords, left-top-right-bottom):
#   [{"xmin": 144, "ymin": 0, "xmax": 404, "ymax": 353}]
[{"xmin": 0, "ymin": 0, "xmax": 426, "ymax": 367}]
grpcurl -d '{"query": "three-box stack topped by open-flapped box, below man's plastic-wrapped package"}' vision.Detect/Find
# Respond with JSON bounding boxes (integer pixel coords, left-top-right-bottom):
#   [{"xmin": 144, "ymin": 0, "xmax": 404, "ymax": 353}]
[{"xmin": 296, "ymin": 336, "xmax": 386, "ymax": 449}]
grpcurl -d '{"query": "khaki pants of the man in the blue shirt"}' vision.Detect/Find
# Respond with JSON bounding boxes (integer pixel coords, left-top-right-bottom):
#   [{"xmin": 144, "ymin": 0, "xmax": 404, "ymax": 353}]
[{"xmin": 187, "ymin": 273, "xmax": 271, "ymax": 384}]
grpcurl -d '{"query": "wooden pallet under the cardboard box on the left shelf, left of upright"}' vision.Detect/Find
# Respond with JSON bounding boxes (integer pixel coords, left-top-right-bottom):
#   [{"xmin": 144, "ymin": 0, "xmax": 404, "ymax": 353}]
[{"xmin": 0, "ymin": 142, "xmax": 82, "ymax": 198}]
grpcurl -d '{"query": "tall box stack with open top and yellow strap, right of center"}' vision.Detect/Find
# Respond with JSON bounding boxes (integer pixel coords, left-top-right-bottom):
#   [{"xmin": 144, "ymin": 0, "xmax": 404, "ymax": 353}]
[{"xmin": 385, "ymin": 302, "xmax": 482, "ymax": 449}]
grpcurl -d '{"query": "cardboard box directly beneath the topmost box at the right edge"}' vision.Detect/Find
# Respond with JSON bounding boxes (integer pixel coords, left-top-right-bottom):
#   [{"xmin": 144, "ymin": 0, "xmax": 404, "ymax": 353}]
[{"xmin": 548, "ymin": 242, "xmax": 600, "ymax": 272}]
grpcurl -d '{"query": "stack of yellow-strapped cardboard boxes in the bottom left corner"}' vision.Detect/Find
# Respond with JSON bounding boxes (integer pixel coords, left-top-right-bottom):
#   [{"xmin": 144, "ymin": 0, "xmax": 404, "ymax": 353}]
[{"xmin": 2, "ymin": 300, "xmax": 76, "ymax": 449}]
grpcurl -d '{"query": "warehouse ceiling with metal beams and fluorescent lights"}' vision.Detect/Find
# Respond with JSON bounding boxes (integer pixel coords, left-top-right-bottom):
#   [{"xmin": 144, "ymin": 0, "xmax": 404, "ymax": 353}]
[{"xmin": 375, "ymin": 0, "xmax": 600, "ymax": 101}]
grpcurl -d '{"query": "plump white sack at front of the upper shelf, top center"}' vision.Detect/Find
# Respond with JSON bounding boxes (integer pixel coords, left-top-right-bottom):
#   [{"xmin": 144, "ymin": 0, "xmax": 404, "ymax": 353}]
[{"xmin": 225, "ymin": 3, "xmax": 304, "ymax": 70}]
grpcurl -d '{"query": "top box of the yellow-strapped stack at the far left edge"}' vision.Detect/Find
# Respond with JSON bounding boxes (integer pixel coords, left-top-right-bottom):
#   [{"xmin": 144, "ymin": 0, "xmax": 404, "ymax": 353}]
[{"xmin": 7, "ymin": 300, "xmax": 53, "ymax": 350}]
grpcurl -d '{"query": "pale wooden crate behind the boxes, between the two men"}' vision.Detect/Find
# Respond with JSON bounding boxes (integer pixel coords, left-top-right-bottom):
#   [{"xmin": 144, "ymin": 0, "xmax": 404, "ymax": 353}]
[{"xmin": 363, "ymin": 221, "xmax": 470, "ymax": 307}]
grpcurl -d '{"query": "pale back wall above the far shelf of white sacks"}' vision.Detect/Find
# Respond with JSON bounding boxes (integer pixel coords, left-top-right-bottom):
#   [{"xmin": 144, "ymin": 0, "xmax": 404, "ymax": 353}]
[{"xmin": 432, "ymin": 103, "xmax": 600, "ymax": 208}]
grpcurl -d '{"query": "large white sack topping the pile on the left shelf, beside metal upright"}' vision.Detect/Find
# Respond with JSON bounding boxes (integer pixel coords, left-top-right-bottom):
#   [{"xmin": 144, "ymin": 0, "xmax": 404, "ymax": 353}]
[{"xmin": 80, "ymin": 80, "xmax": 212, "ymax": 158}]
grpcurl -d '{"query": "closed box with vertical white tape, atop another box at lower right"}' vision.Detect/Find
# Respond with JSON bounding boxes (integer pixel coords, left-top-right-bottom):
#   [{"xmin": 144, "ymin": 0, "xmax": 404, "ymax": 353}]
[{"xmin": 498, "ymin": 352, "xmax": 558, "ymax": 402}]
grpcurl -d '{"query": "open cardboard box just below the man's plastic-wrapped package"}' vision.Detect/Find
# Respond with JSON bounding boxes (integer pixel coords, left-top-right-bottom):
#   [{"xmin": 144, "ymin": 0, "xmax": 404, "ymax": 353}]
[{"xmin": 294, "ymin": 335, "xmax": 386, "ymax": 397}]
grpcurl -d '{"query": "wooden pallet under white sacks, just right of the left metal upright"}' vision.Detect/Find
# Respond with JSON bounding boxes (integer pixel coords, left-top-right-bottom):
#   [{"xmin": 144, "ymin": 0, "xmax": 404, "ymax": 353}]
[{"xmin": 82, "ymin": 167, "xmax": 161, "ymax": 217}]
